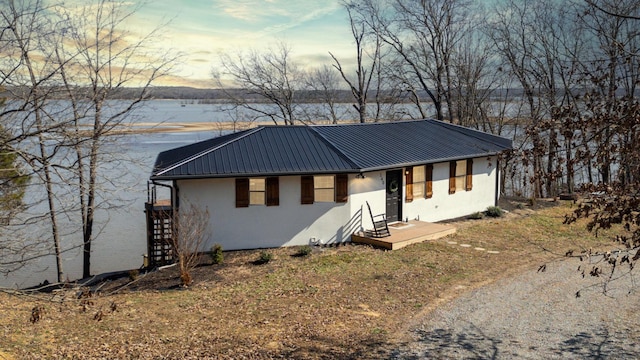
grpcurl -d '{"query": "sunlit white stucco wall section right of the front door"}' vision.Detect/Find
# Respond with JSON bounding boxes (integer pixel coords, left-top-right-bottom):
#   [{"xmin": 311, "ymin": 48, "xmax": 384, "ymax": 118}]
[{"xmin": 403, "ymin": 157, "xmax": 497, "ymax": 222}]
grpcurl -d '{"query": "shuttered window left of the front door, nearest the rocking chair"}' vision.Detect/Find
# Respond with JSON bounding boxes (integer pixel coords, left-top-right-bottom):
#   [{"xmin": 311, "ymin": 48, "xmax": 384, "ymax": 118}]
[{"xmin": 300, "ymin": 174, "xmax": 349, "ymax": 204}]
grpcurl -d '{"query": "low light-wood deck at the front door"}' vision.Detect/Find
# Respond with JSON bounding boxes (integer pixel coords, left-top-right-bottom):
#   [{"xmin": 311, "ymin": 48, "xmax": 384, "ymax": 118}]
[{"xmin": 351, "ymin": 220, "xmax": 456, "ymax": 250}]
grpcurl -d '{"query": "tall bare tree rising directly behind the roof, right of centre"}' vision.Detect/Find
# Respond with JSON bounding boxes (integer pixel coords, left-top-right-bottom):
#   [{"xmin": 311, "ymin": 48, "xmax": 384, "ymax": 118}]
[{"xmin": 356, "ymin": 0, "xmax": 470, "ymax": 120}]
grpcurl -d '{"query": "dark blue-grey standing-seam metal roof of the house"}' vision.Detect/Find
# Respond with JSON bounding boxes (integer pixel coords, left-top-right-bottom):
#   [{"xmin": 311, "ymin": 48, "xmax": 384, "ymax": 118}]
[{"xmin": 151, "ymin": 120, "xmax": 512, "ymax": 180}]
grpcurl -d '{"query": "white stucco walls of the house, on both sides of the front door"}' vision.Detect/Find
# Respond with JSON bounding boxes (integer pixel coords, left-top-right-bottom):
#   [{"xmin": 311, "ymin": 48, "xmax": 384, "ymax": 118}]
[{"xmin": 178, "ymin": 157, "xmax": 497, "ymax": 250}]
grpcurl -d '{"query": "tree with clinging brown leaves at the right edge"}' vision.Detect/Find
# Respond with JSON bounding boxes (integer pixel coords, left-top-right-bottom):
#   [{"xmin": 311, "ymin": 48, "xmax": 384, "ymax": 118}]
[{"xmin": 558, "ymin": 0, "xmax": 640, "ymax": 296}]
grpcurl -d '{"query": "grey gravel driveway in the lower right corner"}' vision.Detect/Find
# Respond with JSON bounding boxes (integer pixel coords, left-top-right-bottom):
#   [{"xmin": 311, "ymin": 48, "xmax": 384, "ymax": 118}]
[{"xmin": 392, "ymin": 260, "xmax": 640, "ymax": 359}]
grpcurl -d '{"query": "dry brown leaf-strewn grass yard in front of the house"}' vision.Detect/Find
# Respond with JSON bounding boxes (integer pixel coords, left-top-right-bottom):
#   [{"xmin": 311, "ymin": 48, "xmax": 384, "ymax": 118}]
[{"xmin": 0, "ymin": 204, "xmax": 610, "ymax": 359}]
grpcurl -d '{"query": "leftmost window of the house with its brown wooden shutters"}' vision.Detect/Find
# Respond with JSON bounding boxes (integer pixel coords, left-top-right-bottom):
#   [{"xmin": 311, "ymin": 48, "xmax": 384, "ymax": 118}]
[{"xmin": 236, "ymin": 177, "xmax": 280, "ymax": 207}]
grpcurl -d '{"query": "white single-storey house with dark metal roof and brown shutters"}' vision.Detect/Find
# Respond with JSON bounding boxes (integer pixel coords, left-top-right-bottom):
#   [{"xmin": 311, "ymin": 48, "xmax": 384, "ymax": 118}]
[{"xmin": 147, "ymin": 120, "xmax": 512, "ymax": 262}]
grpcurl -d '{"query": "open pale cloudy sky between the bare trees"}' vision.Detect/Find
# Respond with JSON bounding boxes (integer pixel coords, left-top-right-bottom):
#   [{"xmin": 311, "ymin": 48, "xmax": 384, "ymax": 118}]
[{"xmin": 127, "ymin": 0, "xmax": 355, "ymax": 88}]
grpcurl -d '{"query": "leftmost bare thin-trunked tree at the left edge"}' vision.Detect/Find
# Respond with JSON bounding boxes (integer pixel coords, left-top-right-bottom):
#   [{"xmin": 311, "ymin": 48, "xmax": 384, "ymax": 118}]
[{"xmin": 0, "ymin": 0, "xmax": 66, "ymax": 281}]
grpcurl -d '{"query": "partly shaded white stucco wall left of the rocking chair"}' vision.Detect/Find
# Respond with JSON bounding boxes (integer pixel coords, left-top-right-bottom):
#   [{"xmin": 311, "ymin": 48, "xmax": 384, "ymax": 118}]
[{"xmin": 178, "ymin": 175, "xmax": 361, "ymax": 250}]
